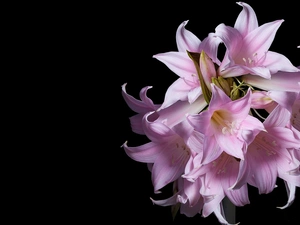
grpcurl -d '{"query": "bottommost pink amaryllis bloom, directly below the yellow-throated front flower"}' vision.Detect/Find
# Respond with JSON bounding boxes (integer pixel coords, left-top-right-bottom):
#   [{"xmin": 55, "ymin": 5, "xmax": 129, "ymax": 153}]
[{"xmin": 182, "ymin": 152, "xmax": 250, "ymax": 224}]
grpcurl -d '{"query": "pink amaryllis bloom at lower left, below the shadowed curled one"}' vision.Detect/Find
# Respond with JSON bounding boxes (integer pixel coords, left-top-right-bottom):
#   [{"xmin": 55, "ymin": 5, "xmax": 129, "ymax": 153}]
[{"xmin": 123, "ymin": 117, "xmax": 193, "ymax": 193}]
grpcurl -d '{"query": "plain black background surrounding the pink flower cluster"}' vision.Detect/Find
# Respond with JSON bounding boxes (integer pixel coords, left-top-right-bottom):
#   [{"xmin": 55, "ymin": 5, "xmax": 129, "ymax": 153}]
[{"xmin": 2, "ymin": 0, "xmax": 300, "ymax": 225}]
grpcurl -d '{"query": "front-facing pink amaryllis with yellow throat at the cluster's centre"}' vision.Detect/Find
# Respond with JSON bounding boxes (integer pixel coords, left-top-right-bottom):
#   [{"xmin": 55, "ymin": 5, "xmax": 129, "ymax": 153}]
[{"xmin": 187, "ymin": 84, "xmax": 264, "ymax": 164}]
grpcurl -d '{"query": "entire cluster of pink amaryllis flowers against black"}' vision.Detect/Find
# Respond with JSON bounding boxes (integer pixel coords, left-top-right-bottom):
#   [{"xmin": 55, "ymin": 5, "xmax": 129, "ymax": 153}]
[{"xmin": 122, "ymin": 2, "xmax": 300, "ymax": 224}]
